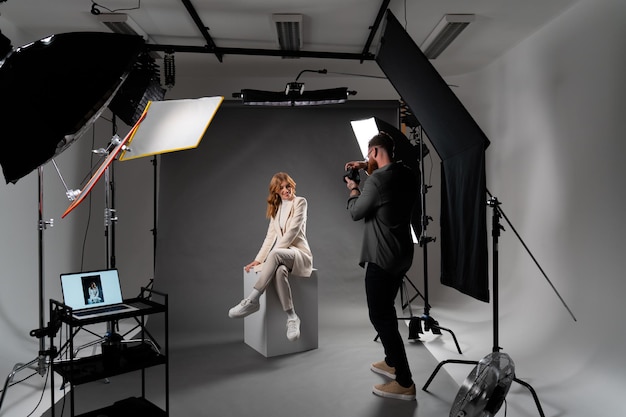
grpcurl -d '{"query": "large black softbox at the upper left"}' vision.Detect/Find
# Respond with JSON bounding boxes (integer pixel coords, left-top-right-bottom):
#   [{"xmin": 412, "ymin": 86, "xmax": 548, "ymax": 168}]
[{"xmin": 0, "ymin": 32, "xmax": 145, "ymax": 183}]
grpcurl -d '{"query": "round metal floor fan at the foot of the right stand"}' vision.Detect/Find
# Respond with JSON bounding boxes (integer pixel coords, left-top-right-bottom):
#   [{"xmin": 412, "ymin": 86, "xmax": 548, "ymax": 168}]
[{"xmin": 450, "ymin": 352, "xmax": 515, "ymax": 417}]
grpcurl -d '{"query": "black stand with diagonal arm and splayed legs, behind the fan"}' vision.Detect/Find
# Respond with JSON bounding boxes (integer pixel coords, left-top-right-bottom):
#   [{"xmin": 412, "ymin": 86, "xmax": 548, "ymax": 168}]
[{"xmin": 422, "ymin": 196, "xmax": 564, "ymax": 417}]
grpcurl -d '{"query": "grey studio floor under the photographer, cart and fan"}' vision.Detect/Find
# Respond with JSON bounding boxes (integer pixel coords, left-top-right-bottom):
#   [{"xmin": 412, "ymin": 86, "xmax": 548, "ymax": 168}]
[{"xmin": 0, "ymin": 288, "xmax": 567, "ymax": 417}]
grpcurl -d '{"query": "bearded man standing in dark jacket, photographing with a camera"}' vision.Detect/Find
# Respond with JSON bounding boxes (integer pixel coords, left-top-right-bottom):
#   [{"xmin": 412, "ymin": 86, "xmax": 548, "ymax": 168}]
[{"xmin": 344, "ymin": 132, "xmax": 418, "ymax": 400}]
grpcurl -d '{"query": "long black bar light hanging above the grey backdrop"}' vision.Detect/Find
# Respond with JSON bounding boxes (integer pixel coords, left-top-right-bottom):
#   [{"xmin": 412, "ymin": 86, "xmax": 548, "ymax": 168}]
[{"xmin": 233, "ymin": 69, "xmax": 356, "ymax": 106}]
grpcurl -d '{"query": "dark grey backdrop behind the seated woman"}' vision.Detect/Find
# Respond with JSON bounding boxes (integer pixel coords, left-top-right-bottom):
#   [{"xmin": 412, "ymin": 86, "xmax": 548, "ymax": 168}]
[{"xmin": 155, "ymin": 101, "xmax": 398, "ymax": 344}]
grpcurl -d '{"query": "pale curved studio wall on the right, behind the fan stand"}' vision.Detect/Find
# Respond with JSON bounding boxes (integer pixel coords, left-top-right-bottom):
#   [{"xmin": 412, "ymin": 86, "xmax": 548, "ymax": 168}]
[{"xmin": 422, "ymin": 0, "xmax": 626, "ymax": 416}]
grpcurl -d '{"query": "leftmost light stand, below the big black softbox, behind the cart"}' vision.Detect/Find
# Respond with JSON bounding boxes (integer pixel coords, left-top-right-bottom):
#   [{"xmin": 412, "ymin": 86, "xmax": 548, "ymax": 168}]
[{"xmin": 0, "ymin": 166, "xmax": 56, "ymax": 409}]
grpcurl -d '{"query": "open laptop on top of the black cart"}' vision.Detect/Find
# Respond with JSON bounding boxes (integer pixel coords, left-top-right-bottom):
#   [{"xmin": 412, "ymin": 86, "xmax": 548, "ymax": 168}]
[{"xmin": 61, "ymin": 269, "xmax": 137, "ymax": 319}]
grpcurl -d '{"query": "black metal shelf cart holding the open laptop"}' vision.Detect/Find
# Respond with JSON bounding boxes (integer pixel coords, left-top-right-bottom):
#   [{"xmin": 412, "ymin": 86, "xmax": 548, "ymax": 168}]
[{"xmin": 50, "ymin": 287, "xmax": 169, "ymax": 417}]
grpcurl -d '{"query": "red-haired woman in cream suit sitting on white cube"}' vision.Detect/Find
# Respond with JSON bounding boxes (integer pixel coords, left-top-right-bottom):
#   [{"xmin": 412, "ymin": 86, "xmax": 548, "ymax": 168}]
[{"xmin": 228, "ymin": 172, "xmax": 313, "ymax": 341}]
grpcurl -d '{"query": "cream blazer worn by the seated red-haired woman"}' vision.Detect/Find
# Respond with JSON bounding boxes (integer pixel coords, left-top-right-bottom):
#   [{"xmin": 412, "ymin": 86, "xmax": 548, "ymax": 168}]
[{"xmin": 254, "ymin": 197, "xmax": 313, "ymax": 277}]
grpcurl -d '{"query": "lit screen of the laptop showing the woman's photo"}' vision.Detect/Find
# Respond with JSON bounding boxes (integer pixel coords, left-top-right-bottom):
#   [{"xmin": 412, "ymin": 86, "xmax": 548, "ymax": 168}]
[{"xmin": 61, "ymin": 269, "xmax": 122, "ymax": 310}]
